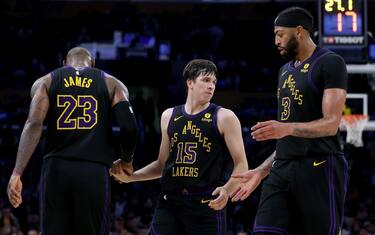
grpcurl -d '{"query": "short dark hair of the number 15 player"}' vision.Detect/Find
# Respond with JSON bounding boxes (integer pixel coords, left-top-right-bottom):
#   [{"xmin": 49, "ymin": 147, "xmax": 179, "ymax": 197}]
[{"xmin": 182, "ymin": 59, "xmax": 218, "ymax": 81}]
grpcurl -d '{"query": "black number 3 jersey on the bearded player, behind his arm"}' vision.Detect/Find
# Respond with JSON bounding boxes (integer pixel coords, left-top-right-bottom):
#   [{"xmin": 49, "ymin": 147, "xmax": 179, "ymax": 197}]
[{"xmin": 276, "ymin": 47, "xmax": 347, "ymax": 158}]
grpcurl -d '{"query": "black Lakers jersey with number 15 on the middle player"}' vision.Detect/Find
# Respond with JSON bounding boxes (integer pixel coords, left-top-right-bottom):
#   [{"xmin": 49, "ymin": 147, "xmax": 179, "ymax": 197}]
[{"xmin": 161, "ymin": 104, "xmax": 229, "ymax": 191}]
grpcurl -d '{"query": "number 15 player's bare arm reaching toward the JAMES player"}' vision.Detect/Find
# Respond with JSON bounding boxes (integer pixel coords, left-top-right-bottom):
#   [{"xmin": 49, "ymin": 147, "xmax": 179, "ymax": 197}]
[{"xmin": 111, "ymin": 108, "xmax": 173, "ymax": 183}]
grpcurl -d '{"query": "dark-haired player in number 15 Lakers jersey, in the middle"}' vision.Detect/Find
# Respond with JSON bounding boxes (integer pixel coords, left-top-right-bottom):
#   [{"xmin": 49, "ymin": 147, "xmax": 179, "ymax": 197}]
[{"xmin": 111, "ymin": 59, "xmax": 248, "ymax": 235}]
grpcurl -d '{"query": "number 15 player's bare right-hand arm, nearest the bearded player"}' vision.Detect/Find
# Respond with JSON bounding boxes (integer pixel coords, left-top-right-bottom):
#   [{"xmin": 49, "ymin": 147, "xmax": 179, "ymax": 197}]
[{"xmin": 209, "ymin": 108, "xmax": 248, "ymax": 210}]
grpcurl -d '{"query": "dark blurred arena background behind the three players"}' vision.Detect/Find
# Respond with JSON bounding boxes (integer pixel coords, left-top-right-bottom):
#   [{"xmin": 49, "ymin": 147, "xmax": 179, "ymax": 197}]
[{"xmin": 0, "ymin": 0, "xmax": 375, "ymax": 235}]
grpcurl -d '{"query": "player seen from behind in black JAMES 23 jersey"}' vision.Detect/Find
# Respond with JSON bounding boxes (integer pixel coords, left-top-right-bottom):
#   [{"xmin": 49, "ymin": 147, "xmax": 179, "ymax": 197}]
[{"xmin": 8, "ymin": 47, "xmax": 137, "ymax": 235}]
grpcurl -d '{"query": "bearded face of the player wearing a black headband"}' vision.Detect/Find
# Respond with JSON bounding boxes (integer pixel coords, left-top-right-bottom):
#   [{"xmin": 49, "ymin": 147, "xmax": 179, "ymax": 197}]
[{"xmin": 274, "ymin": 26, "xmax": 298, "ymax": 60}]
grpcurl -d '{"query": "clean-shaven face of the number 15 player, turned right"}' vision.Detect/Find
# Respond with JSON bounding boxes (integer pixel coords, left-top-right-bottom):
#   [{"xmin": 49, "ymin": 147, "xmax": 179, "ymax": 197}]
[{"xmin": 188, "ymin": 74, "xmax": 217, "ymax": 102}]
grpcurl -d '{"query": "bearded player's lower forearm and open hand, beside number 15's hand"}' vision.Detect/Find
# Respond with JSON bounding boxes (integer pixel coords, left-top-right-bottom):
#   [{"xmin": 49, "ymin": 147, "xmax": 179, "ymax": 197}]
[{"xmin": 231, "ymin": 151, "xmax": 276, "ymax": 202}]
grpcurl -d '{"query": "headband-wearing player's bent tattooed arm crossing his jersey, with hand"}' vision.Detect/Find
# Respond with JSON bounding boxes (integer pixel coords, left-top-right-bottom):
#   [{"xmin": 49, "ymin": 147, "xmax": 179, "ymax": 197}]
[{"xmin": 251, "ymin": 88, "xmax": 346, "ymax": 141}]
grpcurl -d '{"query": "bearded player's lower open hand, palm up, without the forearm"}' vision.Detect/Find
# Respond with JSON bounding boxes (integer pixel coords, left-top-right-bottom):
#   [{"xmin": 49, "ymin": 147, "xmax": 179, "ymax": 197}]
[{"xmin": 230, "ymin": 168, "xmax": 267, "ymax": 202}]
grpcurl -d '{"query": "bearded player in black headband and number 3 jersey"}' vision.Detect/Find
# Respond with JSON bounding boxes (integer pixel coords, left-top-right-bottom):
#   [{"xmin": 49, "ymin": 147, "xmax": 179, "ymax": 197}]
[{"xmin": 232, "ymin": 7, "xmax": 348, "ymax": 235}]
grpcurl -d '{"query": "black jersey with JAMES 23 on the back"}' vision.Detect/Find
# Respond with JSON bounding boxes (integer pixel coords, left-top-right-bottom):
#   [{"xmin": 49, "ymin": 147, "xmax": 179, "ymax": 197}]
[{"xmin": 45, "ymin": 66, "xmax": 113, "ymax": 166}]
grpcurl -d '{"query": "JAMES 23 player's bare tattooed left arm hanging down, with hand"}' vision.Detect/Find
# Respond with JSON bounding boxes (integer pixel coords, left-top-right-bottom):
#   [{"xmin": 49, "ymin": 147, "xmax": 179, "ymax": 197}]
[{"xmin": 7, "ymin": 74, "xmax": 51, "ymax": 207}]
